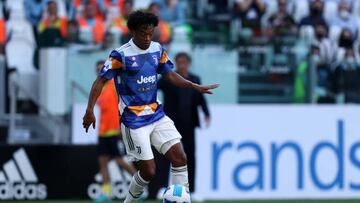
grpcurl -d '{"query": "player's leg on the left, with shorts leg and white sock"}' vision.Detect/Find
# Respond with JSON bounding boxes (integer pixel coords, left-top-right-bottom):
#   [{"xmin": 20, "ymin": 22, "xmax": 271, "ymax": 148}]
[{"xmin": 121, "ymin": 124, "xmax": 155, "ymax": 203}]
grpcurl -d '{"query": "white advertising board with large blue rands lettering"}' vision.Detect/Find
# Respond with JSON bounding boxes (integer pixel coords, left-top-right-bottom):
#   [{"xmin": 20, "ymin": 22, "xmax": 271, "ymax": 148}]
[{"xmin": 196, "ymin": 105, "xmax": 360, "ymax": 199}]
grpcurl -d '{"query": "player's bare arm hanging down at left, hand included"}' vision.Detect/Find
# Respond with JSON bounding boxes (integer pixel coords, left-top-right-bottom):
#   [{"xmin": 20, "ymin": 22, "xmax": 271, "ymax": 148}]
[{"xmin": 83, "ymin": 76, "xmax": 108, "ymax": 132}]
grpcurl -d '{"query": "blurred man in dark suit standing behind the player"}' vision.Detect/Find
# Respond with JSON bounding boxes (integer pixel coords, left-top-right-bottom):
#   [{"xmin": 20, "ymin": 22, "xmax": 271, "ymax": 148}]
[{"xmin": 157, "ymin": 52, "xmax": 210, "ymax": 197}]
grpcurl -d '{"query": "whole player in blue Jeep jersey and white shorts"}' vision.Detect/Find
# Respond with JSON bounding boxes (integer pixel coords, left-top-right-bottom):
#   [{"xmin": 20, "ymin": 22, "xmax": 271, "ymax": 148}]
[{"xmin": 83, "ymin": 11, "xmax": 219, "ymax": 203}]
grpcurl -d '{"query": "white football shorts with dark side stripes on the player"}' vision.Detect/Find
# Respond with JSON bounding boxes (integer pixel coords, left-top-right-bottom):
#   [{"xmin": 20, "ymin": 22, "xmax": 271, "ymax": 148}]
[{"xmin": 121, "ymin": 116, "xmax": 181, "ymax": 161}]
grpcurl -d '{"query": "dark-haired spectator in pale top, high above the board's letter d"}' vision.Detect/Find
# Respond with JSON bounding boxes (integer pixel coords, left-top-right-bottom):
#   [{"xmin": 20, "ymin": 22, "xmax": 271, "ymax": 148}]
[{"xmin": 312, "ymin": 24, "xmax": 336, "ymax": 65}]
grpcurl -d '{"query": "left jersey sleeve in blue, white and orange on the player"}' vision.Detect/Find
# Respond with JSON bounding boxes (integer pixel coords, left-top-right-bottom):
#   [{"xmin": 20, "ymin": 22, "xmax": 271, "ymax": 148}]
[{"xmin": 99, "ymin": 50, "xmax": 123, "ymax": 80}]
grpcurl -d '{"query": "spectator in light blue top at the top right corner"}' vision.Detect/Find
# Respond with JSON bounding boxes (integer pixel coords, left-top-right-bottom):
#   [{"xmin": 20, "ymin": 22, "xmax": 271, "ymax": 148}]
[{"xmin": 329, "ymin": 0, "xmax": 359, "ymax": 37}]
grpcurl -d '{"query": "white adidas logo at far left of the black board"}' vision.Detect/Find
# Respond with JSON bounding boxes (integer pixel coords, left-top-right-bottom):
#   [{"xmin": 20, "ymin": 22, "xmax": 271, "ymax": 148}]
[{"xmin": 0, "ymin": 148, "xmax": 47, "ymax": 200}]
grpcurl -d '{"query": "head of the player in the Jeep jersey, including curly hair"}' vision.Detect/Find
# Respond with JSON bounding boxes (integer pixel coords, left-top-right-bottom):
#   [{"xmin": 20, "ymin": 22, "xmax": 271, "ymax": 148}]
[{"xmin": 127, "ymin": 11, "xmax": 159, "ymax": 50}]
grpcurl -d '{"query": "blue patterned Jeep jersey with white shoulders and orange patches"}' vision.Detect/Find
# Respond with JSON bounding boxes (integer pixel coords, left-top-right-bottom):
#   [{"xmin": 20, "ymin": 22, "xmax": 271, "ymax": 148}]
[{"xmin": 99, "ymin": 40, "xmax": 173, "ymax": 129}]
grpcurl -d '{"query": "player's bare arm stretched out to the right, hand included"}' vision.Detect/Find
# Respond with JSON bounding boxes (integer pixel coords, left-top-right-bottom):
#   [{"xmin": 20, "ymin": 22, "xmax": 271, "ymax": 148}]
[{"xmin": 164, "ymin": 71, "xmax": 220, "ymax": 94}]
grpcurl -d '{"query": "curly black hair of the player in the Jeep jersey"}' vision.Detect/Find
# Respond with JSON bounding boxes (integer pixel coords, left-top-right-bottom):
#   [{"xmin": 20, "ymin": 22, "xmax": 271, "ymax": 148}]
[{"xmin": 127, "ymin": 11, "xmax": 159, "ymax": 30}]
